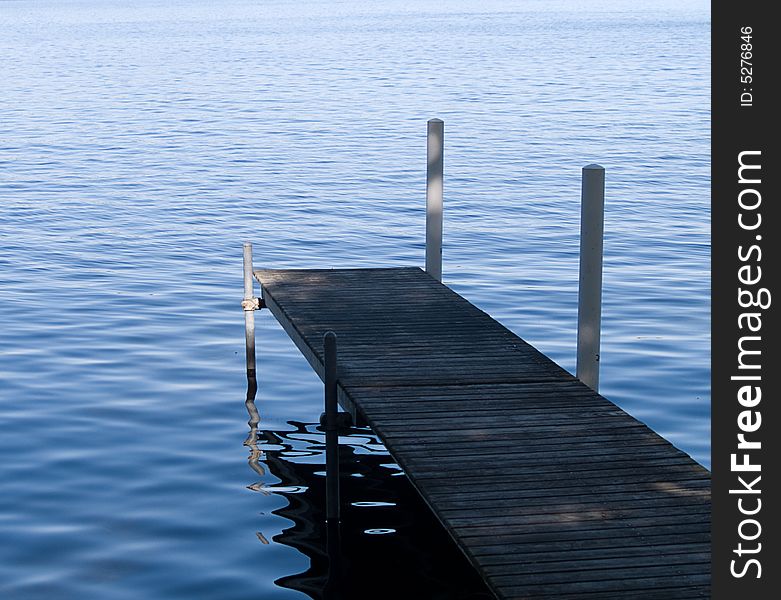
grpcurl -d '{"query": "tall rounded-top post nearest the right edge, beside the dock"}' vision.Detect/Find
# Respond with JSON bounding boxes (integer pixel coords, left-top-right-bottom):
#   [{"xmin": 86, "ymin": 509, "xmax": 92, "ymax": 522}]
[{"xmin": 576, "ymin": 165, "xmax": 605, "ymax": 391}]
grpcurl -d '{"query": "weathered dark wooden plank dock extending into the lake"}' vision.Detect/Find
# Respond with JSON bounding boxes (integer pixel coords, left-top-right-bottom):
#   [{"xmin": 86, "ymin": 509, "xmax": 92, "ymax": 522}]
[{"xmin": 254, "ymin": 268, "xmax": 710, "ymax": 600}]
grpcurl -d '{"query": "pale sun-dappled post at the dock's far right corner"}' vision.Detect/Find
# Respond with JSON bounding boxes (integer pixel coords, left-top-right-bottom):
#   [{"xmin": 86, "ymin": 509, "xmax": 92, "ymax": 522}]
[{"xmin": 426, "ymin": 119, "xmax": 445, "ymax": 281}]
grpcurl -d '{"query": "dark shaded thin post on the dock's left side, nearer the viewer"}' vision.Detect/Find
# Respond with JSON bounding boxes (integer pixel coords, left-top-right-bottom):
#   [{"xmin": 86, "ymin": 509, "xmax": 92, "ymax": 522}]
[{"xmin": 323, "ymin": 331, "xmax": 339, "ymax": 523}]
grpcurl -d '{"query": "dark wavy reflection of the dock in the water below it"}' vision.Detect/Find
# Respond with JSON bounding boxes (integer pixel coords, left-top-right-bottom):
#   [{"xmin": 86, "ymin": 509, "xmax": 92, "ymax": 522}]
[{"xmin": 244, "ymin": 380, "xmax": 493, "ymax": 600}]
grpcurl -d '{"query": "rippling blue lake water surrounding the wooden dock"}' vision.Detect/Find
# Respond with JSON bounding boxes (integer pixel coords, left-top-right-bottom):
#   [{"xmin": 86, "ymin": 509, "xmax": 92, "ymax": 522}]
[{"xmin": 0, "ymin": 0, "xmax": 710, "ymax": 600}]
